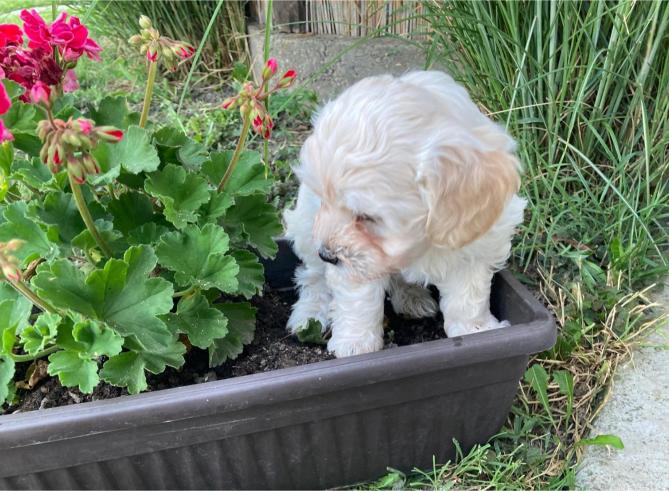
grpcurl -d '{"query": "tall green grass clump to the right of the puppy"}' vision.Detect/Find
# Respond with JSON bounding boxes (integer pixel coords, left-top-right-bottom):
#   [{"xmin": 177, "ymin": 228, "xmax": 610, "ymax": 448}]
[{"xmin": 426, "ymin": 0, "xmax": 669, "ymax": 285}]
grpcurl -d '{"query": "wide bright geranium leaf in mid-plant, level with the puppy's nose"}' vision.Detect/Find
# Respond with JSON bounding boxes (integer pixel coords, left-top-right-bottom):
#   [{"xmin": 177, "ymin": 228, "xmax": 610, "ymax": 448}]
[{"xmin": 156, "ymin": 223, "xmax": 239, "ymax": 293}]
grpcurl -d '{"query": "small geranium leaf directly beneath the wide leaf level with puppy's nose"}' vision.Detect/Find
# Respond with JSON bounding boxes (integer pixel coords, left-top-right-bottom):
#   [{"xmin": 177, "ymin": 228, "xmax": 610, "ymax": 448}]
[{"xmin": 167, "ymin": 293, "xmax": 228, "ymax": 349}]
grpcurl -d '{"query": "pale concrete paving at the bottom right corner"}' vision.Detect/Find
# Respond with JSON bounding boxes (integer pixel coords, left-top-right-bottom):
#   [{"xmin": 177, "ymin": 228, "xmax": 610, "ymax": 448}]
[{"xmin": 576, "ymin": 284, "xmax": 669, "ymax": 490}]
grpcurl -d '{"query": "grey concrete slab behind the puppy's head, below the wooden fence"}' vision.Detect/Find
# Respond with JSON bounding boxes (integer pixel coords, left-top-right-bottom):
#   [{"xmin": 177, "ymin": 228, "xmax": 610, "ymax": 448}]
[{"xmin": 249, "ymin": 26, "xmax": 425, "ymax": 102}]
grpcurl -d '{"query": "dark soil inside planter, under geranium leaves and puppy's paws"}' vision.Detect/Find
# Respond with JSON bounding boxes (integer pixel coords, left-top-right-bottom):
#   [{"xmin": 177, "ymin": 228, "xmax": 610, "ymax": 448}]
[{"xmin": 5, "ymin": 291, "xmax": 446, "ymax": 414}]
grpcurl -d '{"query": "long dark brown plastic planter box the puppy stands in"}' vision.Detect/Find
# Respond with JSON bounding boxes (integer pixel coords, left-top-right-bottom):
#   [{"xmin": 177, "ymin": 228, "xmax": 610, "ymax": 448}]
[{"xmin": 0, "ymin": 238, "xmax": 556, "ymax": 489}]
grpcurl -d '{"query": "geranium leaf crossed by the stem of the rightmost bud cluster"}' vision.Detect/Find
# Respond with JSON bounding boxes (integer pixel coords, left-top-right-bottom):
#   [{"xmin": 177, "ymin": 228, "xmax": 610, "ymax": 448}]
[{"xmin": 202, "ymin": 150, "xmax": 272, "ymax": 196}]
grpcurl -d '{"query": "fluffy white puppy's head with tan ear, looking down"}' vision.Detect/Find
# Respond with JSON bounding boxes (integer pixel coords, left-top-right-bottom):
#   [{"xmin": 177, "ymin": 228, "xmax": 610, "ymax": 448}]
[{"xmin": 297, "ymin": 72, "xmax": 519, "ymax": 281}]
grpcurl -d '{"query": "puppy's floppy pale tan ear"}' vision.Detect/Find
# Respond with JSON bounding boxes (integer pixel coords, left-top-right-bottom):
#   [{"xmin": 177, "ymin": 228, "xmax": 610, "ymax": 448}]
[{"xmin": 418, "ymin": 135, "xmax": 520, "ymax": 249}]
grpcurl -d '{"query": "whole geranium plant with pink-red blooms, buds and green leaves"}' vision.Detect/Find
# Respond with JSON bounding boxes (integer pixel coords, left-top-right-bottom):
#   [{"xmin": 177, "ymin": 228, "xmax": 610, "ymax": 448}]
[{"xmin": 0, "ymin": 10, "xmax": 295, "ymax": 404}]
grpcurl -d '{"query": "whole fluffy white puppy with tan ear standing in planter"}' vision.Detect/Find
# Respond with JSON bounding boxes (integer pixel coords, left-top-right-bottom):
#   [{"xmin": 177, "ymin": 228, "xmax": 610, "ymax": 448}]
[{"xmin": 284, "ymin": 71, "xmax": 525, "ymax": 357}]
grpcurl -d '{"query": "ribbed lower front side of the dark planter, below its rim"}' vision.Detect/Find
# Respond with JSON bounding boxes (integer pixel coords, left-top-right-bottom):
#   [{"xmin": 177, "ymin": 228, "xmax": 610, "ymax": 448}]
[{"xmin": 0, "ymin": 357, "xmax": 527, "ymax": 489}]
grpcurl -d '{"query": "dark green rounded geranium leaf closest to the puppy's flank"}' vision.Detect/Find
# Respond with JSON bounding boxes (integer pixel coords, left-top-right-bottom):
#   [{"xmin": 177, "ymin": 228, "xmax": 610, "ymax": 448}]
[{"xmin": 223, "ymin": 194, "xmax": 283, "ymax": 257}]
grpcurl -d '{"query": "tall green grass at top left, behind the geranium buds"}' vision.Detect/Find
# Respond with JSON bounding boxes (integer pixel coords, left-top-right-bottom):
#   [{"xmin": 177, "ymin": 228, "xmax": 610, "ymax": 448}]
[{"xmin": 75, "ymin": 0, "xmax": 248, "ymax": 75}]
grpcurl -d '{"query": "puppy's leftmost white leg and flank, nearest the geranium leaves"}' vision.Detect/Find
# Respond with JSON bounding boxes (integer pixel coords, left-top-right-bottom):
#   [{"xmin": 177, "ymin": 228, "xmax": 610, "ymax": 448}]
[{"xmin": 284, "ymin": 186, "xmax": 332, "ymax": 334}]
